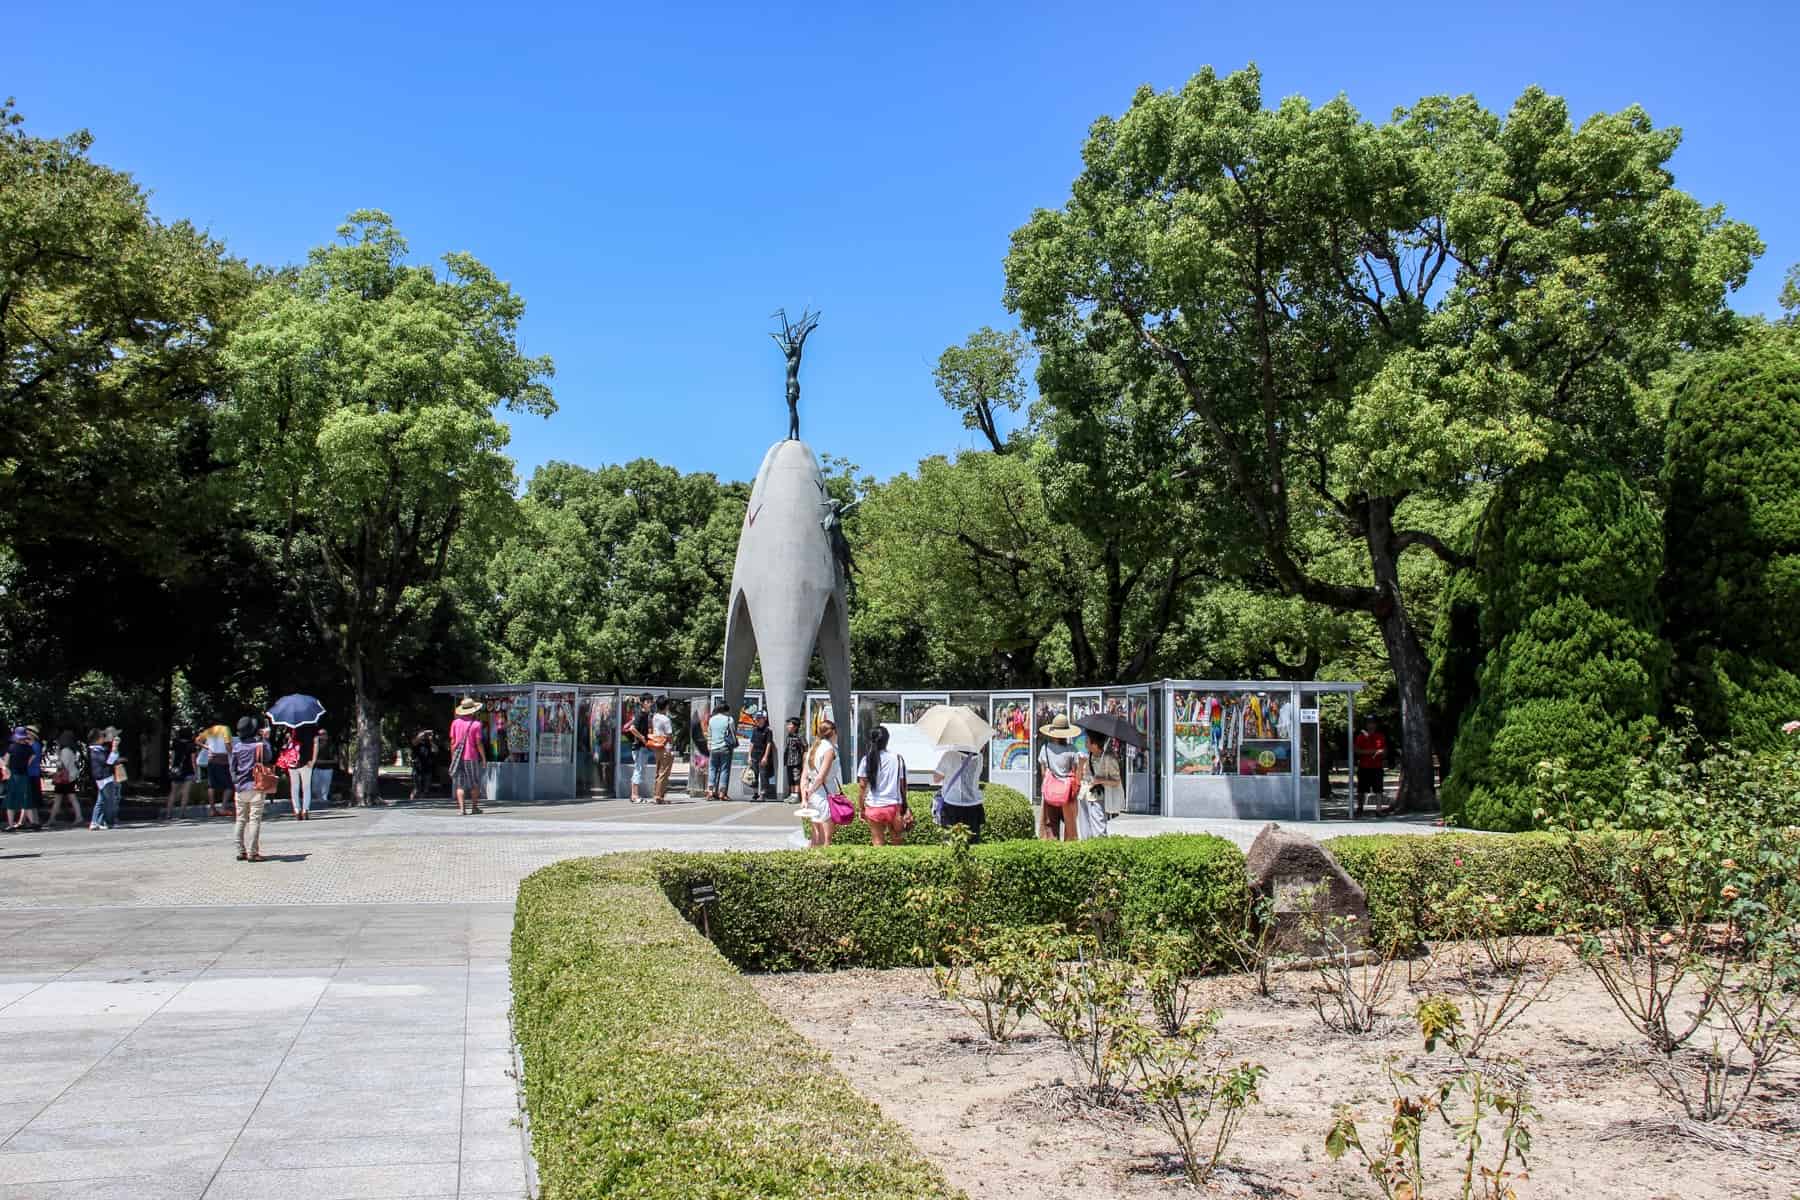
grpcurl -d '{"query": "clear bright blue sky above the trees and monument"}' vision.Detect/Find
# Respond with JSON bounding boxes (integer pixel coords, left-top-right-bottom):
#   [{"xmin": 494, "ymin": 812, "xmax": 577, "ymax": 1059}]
[{"xmin": 0, "ymin": 0, "xmax": 1800, "ymax": 479}]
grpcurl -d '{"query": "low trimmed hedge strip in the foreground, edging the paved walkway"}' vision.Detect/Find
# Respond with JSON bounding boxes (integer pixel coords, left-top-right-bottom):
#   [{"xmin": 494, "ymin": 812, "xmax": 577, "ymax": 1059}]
[{"xmin": 513, "ymin": 855, "xmax": 959, "ymax": 1200}]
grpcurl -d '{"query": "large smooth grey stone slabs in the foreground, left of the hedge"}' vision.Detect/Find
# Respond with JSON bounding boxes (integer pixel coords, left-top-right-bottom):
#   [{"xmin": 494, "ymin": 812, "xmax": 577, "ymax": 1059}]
[{"xmin": 0, "ymin": 903, "xmax": 527, "ymax": 1200}]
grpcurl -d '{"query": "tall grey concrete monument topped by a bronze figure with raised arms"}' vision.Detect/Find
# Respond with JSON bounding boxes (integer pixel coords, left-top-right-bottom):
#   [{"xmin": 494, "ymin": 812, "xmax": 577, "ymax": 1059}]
[{"xmin": 725, "ymin": 313, "xmax": 850, "ymax": 795}]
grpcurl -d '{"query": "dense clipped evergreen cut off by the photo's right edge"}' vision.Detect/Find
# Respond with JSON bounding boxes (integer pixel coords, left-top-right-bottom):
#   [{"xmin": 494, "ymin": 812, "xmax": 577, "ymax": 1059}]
[{"xmin": 1663, "ymin": 329, "xmax": 1800, "ymax": 748}]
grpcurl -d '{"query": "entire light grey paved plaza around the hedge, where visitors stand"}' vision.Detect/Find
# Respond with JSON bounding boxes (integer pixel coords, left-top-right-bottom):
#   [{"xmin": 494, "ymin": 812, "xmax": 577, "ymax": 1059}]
[{"xmin": 0, "ymin": 801, "xmax": 1447, "ymax": 1200}]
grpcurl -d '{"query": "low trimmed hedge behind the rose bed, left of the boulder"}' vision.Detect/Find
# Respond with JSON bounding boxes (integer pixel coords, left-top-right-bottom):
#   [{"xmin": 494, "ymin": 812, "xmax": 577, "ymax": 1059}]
[{"xmin": 655, "ymin": 833, "xmax": 1246, "ymax": 972}]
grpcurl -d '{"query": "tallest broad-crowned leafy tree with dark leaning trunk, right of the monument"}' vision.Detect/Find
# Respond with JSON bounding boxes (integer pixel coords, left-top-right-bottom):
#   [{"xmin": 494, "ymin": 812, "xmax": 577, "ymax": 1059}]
[{"xmin": 1006, "ymin": 68, "xmax": 1760, "ymax": 806}]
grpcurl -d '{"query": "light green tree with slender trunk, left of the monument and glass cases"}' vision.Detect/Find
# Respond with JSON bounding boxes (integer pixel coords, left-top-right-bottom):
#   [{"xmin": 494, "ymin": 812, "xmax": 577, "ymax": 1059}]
[{"xmin": 221, "ymin": 210, "xmax": 554, "ymax": 797}]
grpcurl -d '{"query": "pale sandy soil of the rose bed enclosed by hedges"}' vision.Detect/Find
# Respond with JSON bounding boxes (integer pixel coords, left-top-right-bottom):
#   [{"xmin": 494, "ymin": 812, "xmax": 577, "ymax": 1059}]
[{"xmin": 752, "ymin": 949, "xmax": 1800, "ymax": 1200}]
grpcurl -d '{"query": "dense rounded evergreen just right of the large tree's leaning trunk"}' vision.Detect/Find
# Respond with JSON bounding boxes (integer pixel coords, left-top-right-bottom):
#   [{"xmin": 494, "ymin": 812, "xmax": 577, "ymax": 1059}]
[{"xmin": 1444, "ymin": 461, "xmax": 1669, "ymax": 829}]
